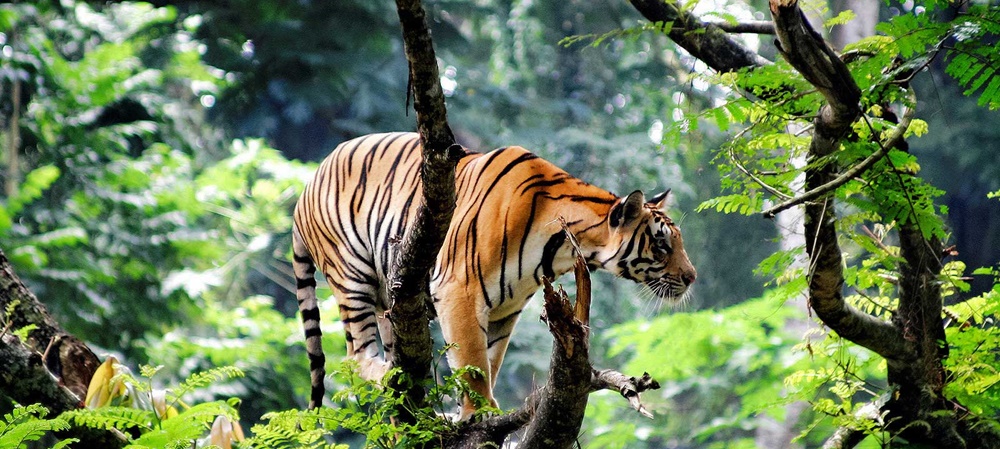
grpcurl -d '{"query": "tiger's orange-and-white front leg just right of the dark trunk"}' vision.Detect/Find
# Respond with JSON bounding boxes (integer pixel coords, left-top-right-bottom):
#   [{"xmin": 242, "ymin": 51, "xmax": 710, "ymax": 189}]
[{"xmin": 437, "ymin": 301, "xmax": 497, "ymax": 420}]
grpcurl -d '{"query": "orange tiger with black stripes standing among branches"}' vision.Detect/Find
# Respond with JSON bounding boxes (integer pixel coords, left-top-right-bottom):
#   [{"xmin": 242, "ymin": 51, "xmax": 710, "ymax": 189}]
[{"xmin": 292, "ymin": 132, "xmax": 697, "ymax": 417}]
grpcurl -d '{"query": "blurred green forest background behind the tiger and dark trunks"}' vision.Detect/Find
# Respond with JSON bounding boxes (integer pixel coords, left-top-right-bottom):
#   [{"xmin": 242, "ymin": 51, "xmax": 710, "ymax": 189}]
[{"xmin": 0, "ymin": 0, "xmax": 1000, "ymax": 448}]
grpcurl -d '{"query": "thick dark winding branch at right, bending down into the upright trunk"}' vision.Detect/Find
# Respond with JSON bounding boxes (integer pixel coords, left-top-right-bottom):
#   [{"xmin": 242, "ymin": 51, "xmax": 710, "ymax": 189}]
[{"xmin": 770, "ymin": 0, "xmax": 913, "ymax": 360}]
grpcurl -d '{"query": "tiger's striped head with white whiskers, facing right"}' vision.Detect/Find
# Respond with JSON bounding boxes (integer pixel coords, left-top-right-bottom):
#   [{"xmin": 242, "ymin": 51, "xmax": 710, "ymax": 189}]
[{"xmin": 591, "ymin": 190, "xmax": 697, "ymax": 301}]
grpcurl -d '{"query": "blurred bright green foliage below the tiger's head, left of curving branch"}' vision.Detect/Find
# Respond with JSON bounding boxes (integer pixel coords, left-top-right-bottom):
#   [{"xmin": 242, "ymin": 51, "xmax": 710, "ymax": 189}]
[{"xmin": 588, "ymin": 292, "xmax": 806, "ymax": 447}]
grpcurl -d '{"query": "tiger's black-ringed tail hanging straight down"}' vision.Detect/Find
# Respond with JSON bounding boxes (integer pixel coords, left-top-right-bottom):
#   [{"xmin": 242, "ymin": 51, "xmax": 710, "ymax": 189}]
[{"xmin": 292, "ymin": 226, "xmax": 326, "ymax": 409}]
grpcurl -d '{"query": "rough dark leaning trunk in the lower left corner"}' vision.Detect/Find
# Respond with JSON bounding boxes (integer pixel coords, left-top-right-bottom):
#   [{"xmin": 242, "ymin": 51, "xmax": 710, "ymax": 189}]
[{"xmin": 0, "ymin": 249, "xmax": 125, "ymax": 448}]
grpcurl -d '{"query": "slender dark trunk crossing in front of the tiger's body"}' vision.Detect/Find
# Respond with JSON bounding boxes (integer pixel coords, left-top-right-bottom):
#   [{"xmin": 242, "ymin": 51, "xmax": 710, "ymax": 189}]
[{"xmin": 389, "ymin": 0, "xmax": 462, "ymax": 422}]
